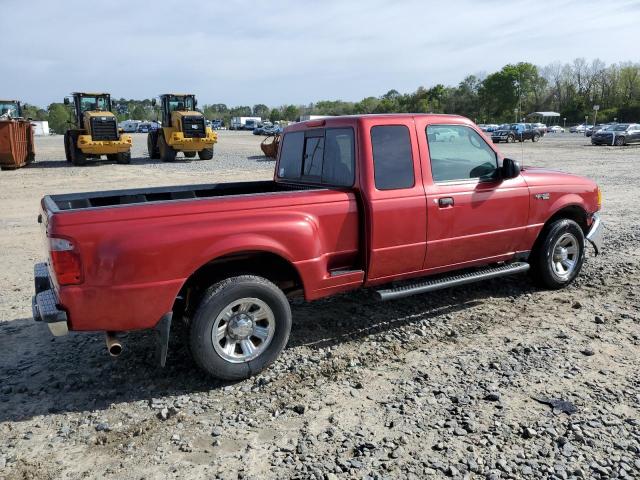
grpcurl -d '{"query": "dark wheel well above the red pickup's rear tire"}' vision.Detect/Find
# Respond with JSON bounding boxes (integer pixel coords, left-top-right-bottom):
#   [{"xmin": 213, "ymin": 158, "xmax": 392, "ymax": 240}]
[{"xmin": 173, "ymin": 252, "xmax": 303, "ymax": 318}]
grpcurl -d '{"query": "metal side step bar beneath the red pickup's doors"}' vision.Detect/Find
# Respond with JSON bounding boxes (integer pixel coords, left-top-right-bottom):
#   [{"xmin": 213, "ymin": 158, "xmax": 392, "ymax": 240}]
[{"xmin": 376, "ymin": 262, "xmax": 529, "ymax": 300}]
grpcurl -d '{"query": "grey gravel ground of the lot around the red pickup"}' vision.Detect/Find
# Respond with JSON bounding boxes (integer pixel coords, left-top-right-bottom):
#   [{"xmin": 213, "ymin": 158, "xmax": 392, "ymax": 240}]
[{"xmin": 0, "ymin": 132, "xmax": 640, "ymax": 480}]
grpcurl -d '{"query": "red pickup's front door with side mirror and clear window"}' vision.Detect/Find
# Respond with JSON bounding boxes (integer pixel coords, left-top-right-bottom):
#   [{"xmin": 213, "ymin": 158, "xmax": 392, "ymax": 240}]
[{"xmin": 417, "ymin": 120, "xmax": 529, "ymax": 270}]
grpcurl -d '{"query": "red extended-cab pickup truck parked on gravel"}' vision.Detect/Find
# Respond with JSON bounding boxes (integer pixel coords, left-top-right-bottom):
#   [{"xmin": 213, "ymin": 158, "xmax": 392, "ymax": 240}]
[{"xmin": 33, "ymin": 114, "xmax": 602, "ymax": 379}]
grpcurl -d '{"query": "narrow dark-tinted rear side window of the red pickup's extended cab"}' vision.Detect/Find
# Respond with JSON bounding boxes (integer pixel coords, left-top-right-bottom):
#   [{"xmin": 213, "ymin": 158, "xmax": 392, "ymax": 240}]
[{"xmin": 371, "ymin": 125, "xmax": 415, "ymax": 190}]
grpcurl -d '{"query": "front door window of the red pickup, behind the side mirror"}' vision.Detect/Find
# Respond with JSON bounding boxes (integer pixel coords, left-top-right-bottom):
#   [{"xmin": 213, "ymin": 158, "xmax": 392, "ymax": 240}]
[{"xmin": 426, "ymin": 125, "xmax": 498, "ymax": 182}]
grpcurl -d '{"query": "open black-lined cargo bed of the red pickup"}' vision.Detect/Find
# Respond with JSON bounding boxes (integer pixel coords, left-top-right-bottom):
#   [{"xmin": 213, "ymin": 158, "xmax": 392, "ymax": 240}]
[{"xmin": 45, "ymin": 180, "xmax": 321, "ymax": 211}]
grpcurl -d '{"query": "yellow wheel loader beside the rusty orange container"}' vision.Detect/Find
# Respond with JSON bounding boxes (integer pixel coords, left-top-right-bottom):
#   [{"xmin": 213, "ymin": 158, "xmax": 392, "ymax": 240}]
[{"xmin": 64, "ymin": 92, "xmax": 132, "ymax": 165}]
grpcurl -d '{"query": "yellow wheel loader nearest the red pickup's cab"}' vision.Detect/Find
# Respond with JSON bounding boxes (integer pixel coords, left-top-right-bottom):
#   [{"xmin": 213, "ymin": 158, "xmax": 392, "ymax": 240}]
[{"xmin": 147, "ymin": 93, "xmax": 218, "ymax": 162}]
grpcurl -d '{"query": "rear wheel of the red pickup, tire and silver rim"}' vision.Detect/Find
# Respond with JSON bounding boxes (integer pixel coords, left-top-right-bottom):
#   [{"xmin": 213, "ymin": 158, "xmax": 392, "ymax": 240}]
[{"xmin": 189, "ymin": 275, "xmax": 291, "ymax": 380}]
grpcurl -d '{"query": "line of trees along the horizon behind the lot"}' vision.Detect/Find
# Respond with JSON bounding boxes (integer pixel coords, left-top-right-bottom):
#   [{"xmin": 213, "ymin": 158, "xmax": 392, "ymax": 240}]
[{"xmin": 25, "ymin": 58, "xmax": 640, "ymax": 133}]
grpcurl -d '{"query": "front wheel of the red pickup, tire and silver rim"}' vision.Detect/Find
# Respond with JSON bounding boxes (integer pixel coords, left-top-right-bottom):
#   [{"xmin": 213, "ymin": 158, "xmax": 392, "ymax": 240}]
[{"xmin": 529, "ymin": 219, "xmax": 585, "ymax": 290}]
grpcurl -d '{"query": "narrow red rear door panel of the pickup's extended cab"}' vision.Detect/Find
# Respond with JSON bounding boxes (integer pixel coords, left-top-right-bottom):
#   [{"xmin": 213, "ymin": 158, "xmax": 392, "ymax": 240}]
[{"xmin": 360, "ymin": 117, "xmax": 427, "ymax": 284}]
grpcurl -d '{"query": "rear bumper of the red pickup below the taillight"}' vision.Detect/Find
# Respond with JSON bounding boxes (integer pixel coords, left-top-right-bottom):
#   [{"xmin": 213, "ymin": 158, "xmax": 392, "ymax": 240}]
[{"xmin": 31, "ymin": 263, "xmax": 69, "ymax": 337}]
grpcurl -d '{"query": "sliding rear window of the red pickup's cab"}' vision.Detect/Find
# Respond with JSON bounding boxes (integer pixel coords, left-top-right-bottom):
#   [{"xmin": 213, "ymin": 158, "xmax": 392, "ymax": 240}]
[{"xmin": 278, "ymin": 128, "xmax": 355, "ymax": 187}]
